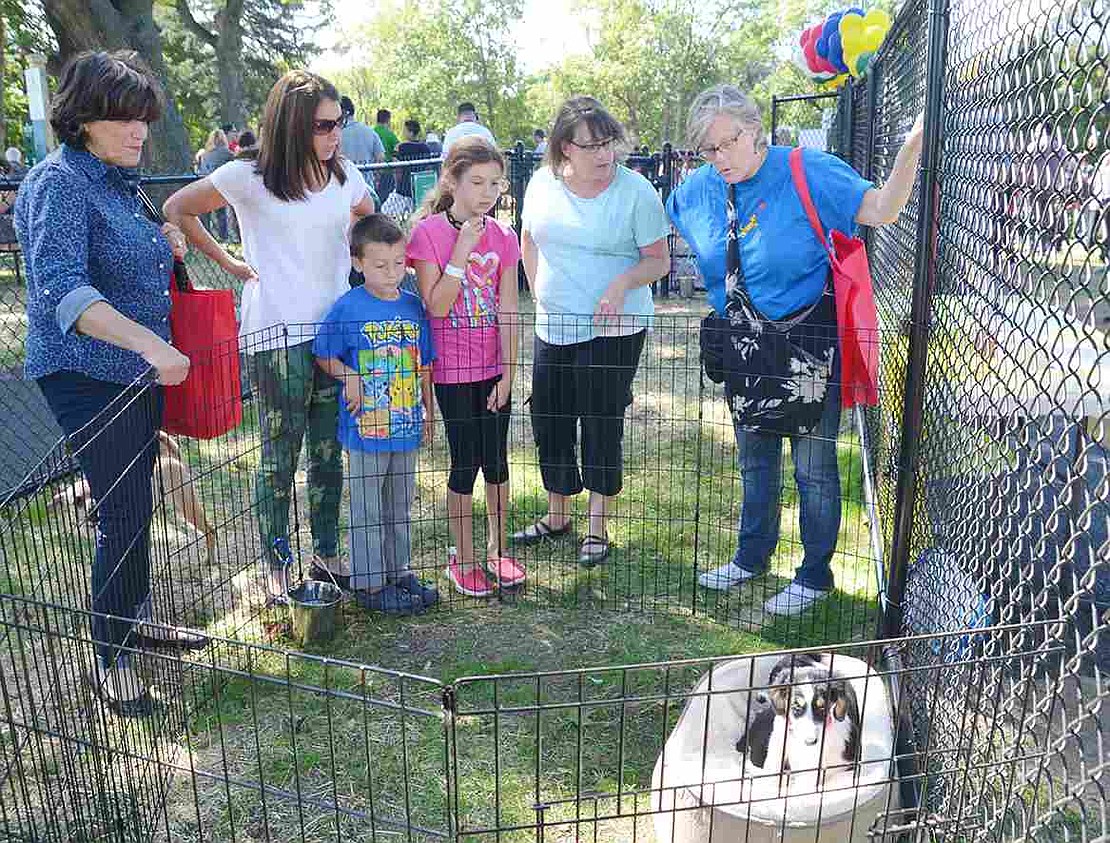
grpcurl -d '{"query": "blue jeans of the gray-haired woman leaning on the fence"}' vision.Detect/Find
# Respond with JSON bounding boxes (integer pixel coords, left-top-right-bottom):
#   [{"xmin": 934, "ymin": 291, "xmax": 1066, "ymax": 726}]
[{"xmin": 733, "ymin": 383, "xmax": 840, "ymax": 591}]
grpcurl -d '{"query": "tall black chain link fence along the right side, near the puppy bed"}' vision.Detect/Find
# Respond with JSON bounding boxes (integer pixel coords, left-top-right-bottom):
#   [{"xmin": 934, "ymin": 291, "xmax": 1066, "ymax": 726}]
[{"xmin": 831, "ymin": 0, "xmax": 1110, "ymax": 841}]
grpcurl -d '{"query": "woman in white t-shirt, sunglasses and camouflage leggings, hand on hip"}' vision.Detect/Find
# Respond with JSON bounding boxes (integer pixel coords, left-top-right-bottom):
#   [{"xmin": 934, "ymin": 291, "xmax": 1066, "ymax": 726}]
[{"xmin": 164, "ymin": 70, "xmax": 374, "ymax": 601}]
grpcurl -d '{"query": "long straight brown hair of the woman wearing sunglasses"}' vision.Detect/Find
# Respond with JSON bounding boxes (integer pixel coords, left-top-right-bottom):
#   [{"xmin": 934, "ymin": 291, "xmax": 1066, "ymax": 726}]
[{"xmin": 255, "ymin": 70, "xmax": 346, "ymax": 201}]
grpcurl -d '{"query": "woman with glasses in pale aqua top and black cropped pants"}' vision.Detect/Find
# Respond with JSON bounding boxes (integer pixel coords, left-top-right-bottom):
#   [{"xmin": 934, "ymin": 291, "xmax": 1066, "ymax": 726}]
[{"xmin": 513, "ymin": 97, "xmax": 670, "ymax": 566}]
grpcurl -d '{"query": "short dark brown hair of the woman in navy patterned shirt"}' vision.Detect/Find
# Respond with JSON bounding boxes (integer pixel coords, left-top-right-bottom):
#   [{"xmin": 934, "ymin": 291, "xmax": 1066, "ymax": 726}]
[{"xmin": 50, "ymin": 50, "xmax": 165, "ymax": 149}]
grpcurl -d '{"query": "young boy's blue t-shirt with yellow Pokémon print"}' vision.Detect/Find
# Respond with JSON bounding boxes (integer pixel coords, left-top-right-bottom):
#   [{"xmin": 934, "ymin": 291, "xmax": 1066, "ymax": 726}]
[{"xmin": 312, "ymin": 287, "xmax": 435, "ymax": 451}]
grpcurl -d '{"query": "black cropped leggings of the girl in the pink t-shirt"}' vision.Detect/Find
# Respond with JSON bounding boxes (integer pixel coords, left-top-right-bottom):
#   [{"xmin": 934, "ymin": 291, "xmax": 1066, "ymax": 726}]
[{"xmin": 435, "ymin": 375, "xmax": 513, "ymax": 494}]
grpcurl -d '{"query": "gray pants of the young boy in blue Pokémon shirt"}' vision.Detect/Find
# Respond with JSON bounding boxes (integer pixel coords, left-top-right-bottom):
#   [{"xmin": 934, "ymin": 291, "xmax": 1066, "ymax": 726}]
[{"xmin": 347, "ymin": 450, "xmax": 416, "ymax": 591}]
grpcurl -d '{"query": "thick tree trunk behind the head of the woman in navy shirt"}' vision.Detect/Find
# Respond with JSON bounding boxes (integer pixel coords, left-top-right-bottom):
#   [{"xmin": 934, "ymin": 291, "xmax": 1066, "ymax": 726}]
[{"xmin": 42, "ymin": 0, "xmax": 192, "ymax": 172}]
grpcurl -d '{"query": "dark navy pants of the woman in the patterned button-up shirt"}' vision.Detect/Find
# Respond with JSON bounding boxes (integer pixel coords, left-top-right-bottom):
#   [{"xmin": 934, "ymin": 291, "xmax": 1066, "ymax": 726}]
[{"xmin": 39, "ymin": 372, "xmax": 162, "ymax": 668}]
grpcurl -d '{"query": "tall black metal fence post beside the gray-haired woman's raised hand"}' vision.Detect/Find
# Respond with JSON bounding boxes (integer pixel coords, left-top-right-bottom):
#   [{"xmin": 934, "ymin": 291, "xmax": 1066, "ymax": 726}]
[{"xmin": 882, "ymin": 0, "xmax": 948, "ymax": 638}]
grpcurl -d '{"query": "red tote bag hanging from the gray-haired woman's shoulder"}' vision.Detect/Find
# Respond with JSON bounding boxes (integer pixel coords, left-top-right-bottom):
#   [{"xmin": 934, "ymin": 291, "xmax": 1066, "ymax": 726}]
[{"xmin": 790, "ymin": 147, "xmax": 879, "ymax": 409}]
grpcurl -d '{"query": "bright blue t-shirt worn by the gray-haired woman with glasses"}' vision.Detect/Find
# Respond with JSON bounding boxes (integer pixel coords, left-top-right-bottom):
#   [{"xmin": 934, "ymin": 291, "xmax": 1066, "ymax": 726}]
[{"xmin": 667, "ymin": 147, "xmax": 875, "ymax": 319}]
